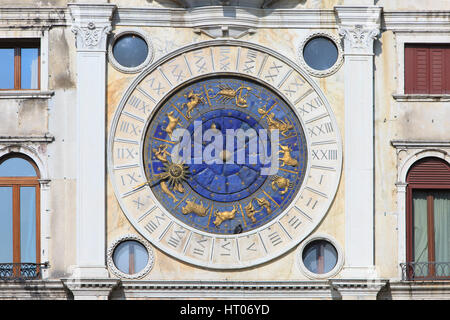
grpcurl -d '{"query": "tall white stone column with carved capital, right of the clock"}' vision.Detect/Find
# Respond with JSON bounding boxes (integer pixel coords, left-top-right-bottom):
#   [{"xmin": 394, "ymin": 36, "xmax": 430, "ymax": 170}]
[{"xmin": 335, "ymin": 6, "xmax": 381, "ymax": 279}]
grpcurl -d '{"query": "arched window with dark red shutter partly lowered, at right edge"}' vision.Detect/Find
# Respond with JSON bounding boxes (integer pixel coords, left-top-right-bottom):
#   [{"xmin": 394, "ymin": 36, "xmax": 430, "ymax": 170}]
[{"xmin": 406, "ymin": 157, "xmax": 450, "ymax": 279}]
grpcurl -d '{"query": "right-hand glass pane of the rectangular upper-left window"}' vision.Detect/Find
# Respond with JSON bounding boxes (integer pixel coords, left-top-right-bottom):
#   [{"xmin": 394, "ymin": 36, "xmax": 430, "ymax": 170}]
[{"xmin": 20, "ymin": 48, "xmax": 39, "ymax": 89}]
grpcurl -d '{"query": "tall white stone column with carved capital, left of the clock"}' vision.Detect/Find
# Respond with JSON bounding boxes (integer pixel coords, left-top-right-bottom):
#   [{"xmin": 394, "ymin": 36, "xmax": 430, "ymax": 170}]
[{"xmin": 68, "ymin": 3, "xmax": 115, "ymax": 279}]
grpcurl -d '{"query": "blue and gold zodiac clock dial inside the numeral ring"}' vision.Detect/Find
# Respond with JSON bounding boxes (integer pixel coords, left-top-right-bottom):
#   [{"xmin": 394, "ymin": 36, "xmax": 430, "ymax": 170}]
[{"xmin": 144, "ymin": 75, "xmax": 307, "ymax": 234}]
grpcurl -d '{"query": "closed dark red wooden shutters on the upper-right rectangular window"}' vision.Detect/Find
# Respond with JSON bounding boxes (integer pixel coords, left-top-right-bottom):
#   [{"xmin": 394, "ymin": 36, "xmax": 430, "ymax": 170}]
[{"xmin": 405, "ymin": 44, "xmax": 450, "ymax": 94}]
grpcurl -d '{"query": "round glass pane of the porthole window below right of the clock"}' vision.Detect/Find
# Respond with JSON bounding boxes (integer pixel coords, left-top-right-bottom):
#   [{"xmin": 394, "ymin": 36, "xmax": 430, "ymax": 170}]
[{"xmin": 302, "ymin": 240, "xmax": 338, "ymax": 274}]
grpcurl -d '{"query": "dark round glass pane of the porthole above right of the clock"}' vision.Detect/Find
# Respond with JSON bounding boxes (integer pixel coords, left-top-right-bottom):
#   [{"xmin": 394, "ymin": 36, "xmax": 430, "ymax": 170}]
[{"xmin": 303, "ymin": 37, "xmax": 338, "ymax": 70}]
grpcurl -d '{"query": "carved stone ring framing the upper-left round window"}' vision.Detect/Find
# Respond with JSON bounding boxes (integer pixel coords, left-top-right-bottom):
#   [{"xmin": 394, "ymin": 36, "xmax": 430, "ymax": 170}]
[{"xmin": 108, "ymin": 28, "xmax": 154, "ymax": 73}]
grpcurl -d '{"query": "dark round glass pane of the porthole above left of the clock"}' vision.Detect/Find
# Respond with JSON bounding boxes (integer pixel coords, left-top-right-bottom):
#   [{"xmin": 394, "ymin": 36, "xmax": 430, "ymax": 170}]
[{"xmin": 113, "ymin": 35, "xmax": 148, "ymax": 68}]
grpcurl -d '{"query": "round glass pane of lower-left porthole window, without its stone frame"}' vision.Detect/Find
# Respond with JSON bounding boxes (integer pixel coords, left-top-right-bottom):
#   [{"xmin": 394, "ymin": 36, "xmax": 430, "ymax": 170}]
[{"xmin": 113, "ymin": 240, "xmax": 148, "ymax": 274}]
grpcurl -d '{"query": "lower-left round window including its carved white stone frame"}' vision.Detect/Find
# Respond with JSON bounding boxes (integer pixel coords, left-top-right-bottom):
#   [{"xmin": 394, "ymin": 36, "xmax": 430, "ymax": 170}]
[{"xmin": 108, "ymin": 235, "xmax": 153, "ymax": 278}]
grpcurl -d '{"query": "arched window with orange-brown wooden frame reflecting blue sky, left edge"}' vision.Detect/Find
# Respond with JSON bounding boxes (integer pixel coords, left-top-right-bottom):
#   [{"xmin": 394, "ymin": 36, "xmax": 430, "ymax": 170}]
[{"xmin": 0, "ymin": 153, "xmax": 40, "ymax": 279}]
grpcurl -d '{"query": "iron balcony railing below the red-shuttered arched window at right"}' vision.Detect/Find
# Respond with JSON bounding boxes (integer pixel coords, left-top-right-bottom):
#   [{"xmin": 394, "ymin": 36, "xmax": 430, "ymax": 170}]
[{"xmin": 400, "ymin": 262, "xmax": 450, "ymax": 280}]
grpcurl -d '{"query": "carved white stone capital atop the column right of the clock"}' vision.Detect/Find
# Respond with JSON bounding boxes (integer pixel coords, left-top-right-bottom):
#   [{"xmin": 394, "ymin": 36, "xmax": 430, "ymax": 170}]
[{"xmin": 335, "ymin": 6, "xmax": 382, "ymax": 55}]
